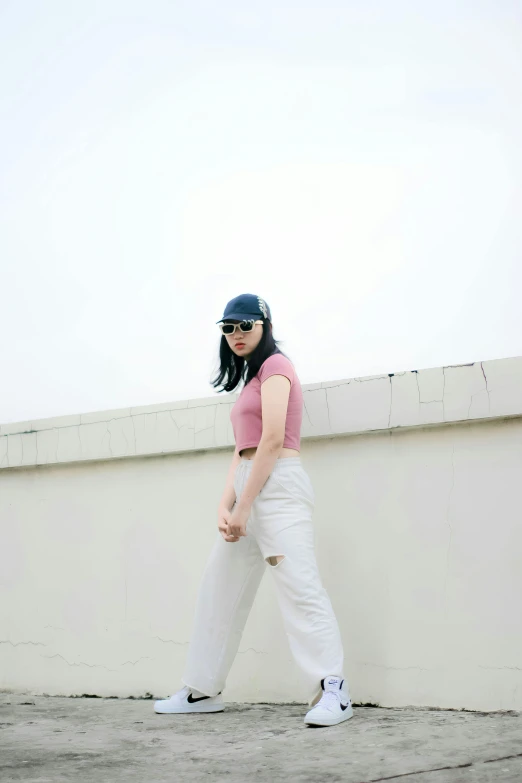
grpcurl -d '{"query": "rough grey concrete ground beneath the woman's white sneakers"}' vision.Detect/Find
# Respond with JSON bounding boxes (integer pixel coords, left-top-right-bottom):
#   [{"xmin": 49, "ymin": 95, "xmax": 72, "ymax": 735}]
[{"xmin": 0, "ymin": 693, "xmax": 522, "ymax": 783}]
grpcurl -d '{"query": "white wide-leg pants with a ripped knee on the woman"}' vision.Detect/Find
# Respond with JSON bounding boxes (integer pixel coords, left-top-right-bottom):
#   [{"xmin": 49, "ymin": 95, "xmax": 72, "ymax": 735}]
[{"xmin": 182, "ymin": 457, "xmax": 349, "ymax": 705}]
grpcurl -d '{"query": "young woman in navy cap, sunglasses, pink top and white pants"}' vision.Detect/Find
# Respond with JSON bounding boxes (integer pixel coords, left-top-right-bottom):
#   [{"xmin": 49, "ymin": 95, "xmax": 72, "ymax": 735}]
[{"xmin": 154, "ymin": 294, "xmax": 353, "ymax": 726}]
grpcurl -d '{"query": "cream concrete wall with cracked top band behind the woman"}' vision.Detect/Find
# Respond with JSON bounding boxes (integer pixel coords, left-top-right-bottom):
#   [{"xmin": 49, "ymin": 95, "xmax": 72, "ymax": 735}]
[{"xmin": 0, "ymin": 358, "xmax": 522, "ymax": 709}]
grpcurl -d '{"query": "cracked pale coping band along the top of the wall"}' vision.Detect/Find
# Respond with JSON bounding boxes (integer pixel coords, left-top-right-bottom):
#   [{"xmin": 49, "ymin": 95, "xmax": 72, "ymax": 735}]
[{"xmin": 0, "ymin": 357, "xmax": 522, "ymax": 469}]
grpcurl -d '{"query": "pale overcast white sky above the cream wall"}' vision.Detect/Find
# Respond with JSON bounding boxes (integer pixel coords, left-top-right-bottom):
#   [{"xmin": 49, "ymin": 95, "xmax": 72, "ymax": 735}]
[{"xmin": 0, "ymin": 0, "xmax": 522, "ymax": 423}]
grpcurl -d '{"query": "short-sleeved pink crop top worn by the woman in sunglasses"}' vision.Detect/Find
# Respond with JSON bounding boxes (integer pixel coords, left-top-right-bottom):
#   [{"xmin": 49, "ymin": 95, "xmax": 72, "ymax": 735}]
[{"xmin": 230, "ymin": 353, "xmax": 303, "ymax": 453}]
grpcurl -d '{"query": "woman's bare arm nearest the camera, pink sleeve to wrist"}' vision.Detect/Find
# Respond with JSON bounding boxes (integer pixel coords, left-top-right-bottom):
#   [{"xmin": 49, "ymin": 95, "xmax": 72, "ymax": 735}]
[{"xmin": 234, "ymin": 375, "xmax": 290, "ymax": 514}]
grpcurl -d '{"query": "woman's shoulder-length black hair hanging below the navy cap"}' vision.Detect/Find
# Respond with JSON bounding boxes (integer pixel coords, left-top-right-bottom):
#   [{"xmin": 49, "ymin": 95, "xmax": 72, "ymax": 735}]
[{"xmin": 210, "ymin": 318, "xmax": 289, "ymax": 393}]
